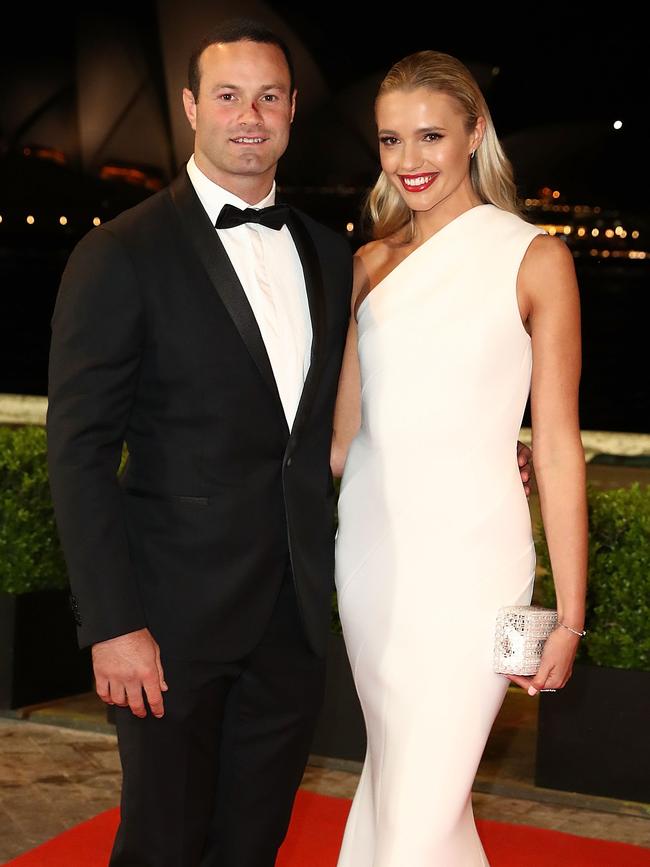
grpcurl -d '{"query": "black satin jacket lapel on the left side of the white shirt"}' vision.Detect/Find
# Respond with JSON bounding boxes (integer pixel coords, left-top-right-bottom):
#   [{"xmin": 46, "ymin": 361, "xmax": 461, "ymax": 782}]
[{"xmin": 169, "ymin": 171, "xmax": 289, "ymax": 432}]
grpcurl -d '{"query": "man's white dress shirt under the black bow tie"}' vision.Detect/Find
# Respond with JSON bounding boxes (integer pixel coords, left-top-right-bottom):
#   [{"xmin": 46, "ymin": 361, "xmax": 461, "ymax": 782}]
[{"xmin": 187, "ymin": 156, "xmax": 312, "ymax": 430}]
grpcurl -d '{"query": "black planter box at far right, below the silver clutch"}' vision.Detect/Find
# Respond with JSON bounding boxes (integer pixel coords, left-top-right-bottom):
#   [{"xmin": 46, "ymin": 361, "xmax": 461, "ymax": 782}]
[{"xmin": 535, "ymin": 665, "xmax": 650, "ymax": 803}]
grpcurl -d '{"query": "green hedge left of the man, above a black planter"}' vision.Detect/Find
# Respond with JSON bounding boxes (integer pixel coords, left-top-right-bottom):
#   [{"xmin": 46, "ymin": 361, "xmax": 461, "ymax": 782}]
[{"xmin": 0, "ymin": 427, "xmax": 68, "ymax": 593}]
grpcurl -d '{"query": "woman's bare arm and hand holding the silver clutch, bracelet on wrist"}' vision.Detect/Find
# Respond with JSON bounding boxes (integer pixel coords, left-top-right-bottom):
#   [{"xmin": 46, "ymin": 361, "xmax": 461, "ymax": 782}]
[{"xmin": 517, "ymin": 236, "xmax": 587, "ymax": 694}]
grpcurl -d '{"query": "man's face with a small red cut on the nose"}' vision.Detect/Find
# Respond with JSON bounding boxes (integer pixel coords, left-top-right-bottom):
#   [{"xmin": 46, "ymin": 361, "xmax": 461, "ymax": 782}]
[{"xmin": 183, "ymin": 41, "xmax": 296, "ymax": 192}]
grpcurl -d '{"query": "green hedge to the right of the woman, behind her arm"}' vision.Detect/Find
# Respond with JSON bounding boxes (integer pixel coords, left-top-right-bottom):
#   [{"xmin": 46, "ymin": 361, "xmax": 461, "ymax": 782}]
[{"xmin": 536, "ymin": 484, "xmax": 650, "ymax": 671}]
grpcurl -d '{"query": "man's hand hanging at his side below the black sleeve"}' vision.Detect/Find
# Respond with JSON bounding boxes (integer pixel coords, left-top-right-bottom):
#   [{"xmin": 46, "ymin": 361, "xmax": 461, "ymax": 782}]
[{"xmin": 92, "ymin": 629, "xmax": 168, "ymax": 718}]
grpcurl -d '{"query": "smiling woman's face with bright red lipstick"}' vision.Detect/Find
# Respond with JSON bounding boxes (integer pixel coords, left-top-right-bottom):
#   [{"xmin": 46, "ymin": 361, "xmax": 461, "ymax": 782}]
[{"xmin": 376, "ymin": 88, "xmax": 484, "ymax": 217}]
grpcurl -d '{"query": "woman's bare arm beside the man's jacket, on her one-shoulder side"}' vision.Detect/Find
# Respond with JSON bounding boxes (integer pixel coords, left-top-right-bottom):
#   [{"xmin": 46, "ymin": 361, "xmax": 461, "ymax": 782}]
[{"xmin": 330, "ymin": 253, "xmax": 368, "ymax": 477}]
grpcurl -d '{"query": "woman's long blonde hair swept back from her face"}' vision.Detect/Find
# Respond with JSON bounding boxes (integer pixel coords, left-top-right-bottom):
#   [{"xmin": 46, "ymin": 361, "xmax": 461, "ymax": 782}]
[{"xmin": 366, "ymin": 51, "xmax": 519, "ymax": 243}]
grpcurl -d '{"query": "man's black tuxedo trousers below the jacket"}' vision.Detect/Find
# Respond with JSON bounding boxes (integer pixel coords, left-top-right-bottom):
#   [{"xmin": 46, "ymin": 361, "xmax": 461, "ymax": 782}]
[{"xmin": 110, "ymin": 577, "xmax": 325, "ymax": 867}]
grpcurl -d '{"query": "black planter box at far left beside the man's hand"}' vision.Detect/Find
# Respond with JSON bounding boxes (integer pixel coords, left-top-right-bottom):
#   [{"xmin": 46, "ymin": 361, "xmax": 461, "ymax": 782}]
[{"xmin": 0, "ymin": 590, "xmax": 93, "ymax": 708}]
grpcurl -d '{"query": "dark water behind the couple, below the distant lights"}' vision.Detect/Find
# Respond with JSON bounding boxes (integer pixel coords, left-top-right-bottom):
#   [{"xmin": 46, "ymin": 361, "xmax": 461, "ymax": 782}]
[{"xmin": 0, "ymin": 203, "xmax": 650, "ymax": 432}]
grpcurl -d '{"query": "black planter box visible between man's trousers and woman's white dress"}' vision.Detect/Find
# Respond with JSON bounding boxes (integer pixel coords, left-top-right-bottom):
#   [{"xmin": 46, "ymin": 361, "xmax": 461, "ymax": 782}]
[{"xmin": 311, "ymin": 635, "xmax": 366, "ymax": 762}]
